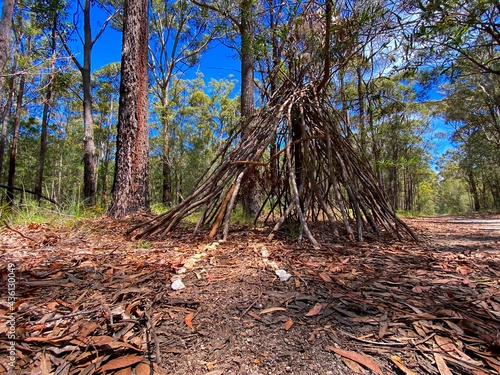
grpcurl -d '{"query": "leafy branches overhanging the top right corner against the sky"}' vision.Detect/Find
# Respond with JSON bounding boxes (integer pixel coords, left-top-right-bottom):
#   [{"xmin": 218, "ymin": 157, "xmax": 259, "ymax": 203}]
[{"xmin": 403, "ymin": 0, "xmax": 500, "ymax": 75}]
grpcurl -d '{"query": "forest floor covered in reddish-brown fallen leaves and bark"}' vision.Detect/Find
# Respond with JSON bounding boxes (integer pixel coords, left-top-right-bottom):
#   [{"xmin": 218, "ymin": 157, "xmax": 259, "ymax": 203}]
[{"xmin": 0, "ymin": 215, "xmax": 500, "ymax": 375}]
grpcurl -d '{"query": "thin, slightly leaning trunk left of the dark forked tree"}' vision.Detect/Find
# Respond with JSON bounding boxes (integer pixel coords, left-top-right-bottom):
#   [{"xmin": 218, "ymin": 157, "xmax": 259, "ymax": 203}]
[{"xmin": 35, "ymin": 16, "xmax": 57, "ymax": 203}]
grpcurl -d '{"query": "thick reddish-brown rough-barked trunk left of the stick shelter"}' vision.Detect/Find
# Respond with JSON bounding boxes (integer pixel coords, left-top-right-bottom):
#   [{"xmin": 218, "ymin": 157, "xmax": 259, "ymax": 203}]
[{"xmin": 108, "ymin": 0, "xmax": 149, "ymax": 218}]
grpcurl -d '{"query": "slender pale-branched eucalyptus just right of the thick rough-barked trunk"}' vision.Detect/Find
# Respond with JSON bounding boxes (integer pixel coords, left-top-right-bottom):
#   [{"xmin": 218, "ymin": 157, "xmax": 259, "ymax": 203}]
[{"xmin": 149, "ymin": 0, "xmax": 216, "ymax": 205}]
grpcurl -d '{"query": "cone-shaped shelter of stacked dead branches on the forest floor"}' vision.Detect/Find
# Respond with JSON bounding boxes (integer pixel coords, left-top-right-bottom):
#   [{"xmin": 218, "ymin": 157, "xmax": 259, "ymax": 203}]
[{"xmin": 130, "ymin": 84, "xmax": 416, "ymax": 246}]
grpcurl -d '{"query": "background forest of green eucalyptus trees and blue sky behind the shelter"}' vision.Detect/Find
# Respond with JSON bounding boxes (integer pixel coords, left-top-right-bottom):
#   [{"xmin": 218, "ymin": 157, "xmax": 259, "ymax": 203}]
[{"xmin": 0, "ymin": 0, "xmax": 500, "ymax": 223}]
